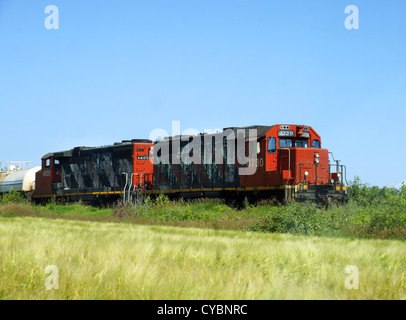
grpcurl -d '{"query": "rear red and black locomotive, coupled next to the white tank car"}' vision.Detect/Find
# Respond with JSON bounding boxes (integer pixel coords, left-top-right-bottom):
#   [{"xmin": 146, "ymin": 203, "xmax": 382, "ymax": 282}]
[{"xmin": 33, "ymin": 139, "xmax": 153, "ymax": 203}]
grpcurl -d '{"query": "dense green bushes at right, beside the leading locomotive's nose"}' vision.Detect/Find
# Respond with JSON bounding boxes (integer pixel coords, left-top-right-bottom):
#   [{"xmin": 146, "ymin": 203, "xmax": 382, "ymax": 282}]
[{"xmin": 250, "ymin": 178, "xmax": 406, "ymax": 239}]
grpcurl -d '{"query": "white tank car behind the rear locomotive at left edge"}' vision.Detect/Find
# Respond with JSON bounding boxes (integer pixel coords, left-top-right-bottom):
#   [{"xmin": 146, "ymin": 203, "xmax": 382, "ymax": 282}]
[{"xmin": 0, "ymin": 165, "xmax": 41, "ymax": 193}]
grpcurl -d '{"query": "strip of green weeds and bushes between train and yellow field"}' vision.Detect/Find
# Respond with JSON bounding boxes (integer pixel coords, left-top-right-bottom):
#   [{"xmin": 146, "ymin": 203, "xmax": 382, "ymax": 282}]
[{"xmin": 0, "ymin": 180, "xmax": 406, "ymax": 240}]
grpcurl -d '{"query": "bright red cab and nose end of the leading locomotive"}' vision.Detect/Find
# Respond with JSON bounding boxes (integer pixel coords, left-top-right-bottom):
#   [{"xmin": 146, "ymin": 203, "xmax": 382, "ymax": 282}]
[{"xmin": 265, "ymin": 125, "xmax": 346, "ymax": 201}]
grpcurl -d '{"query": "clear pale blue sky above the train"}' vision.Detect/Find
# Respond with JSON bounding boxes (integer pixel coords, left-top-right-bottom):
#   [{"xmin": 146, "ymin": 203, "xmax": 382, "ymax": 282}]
[{"xmin": 0, "ymin": 0, "xmax": 406, "ymax": 186}]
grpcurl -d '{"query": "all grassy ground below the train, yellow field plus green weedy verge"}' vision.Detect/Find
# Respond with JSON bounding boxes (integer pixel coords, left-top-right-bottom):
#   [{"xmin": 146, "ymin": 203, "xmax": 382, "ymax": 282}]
[{"xmin": 0, "ymin": 181, "xmax": 406, "ymax": 300}]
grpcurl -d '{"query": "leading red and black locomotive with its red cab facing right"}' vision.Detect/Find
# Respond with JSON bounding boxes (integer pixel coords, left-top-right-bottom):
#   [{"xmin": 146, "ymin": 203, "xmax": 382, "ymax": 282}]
[{"xmin": 152, "ymin": 125, "xmax": 348, "ymax": 203}]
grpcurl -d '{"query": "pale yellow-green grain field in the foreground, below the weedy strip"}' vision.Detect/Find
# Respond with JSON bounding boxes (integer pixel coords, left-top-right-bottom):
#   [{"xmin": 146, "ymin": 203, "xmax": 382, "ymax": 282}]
[{"xmin": 0, "ymin": 215, "xmax": 406, "ymax": 299}]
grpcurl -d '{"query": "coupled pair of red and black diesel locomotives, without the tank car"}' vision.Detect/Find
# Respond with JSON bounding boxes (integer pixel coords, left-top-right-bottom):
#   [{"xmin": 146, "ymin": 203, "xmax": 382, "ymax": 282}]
[{"xmin": 8, "ymin": 124, "xmax": 348, "ymax": 204}]
